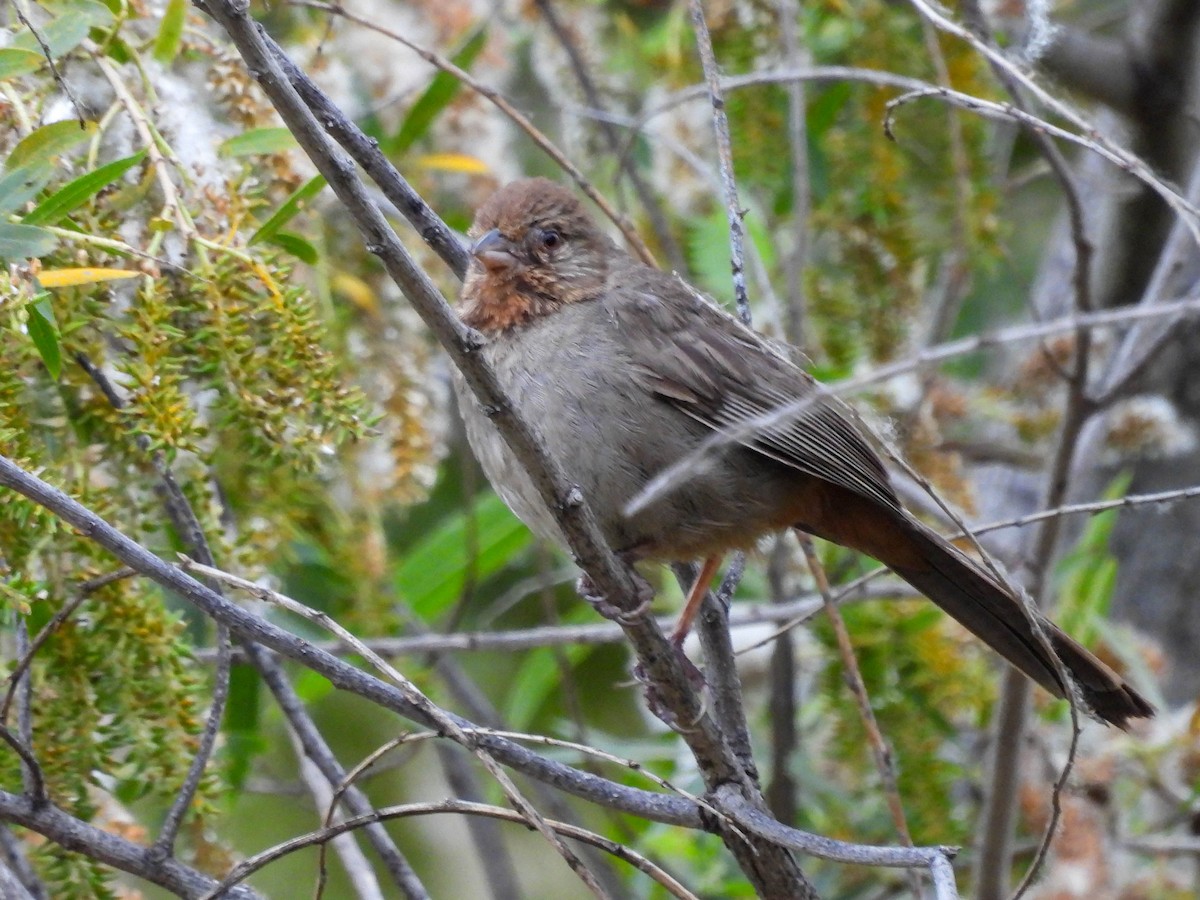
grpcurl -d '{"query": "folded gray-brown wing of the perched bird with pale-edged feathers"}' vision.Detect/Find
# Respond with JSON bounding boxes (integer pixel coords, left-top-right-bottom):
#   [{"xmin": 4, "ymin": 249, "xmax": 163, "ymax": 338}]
[{"xmin": 605, "ymin": 268, "xmax": 899, "ymax": 508}]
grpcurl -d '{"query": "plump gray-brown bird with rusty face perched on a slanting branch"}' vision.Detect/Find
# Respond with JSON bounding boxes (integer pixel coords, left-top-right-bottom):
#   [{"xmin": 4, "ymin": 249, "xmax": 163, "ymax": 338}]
[{"xmin": 457, "ymin": 179, "xmax": 1153, "ymax": 727}]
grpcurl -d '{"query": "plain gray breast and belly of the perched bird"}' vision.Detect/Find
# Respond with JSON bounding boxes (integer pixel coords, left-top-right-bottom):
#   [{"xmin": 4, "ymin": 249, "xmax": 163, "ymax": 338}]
[{"xmin": 455, "ymin": 302, "xmax": 782, "ymax": 558}]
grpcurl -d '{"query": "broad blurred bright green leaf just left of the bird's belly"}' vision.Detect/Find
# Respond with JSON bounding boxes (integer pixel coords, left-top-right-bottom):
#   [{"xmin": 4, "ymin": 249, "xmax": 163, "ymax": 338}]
[{"xmin": 395, "ymin": 493, "xmax": 532, "ymax": 620}]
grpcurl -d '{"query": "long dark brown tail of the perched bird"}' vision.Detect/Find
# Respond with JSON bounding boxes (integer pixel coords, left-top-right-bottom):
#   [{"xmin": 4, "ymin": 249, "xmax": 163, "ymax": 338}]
[{"xmin": 816, "ymin": 514, "xmax": 1154, "ymax": 728}]
